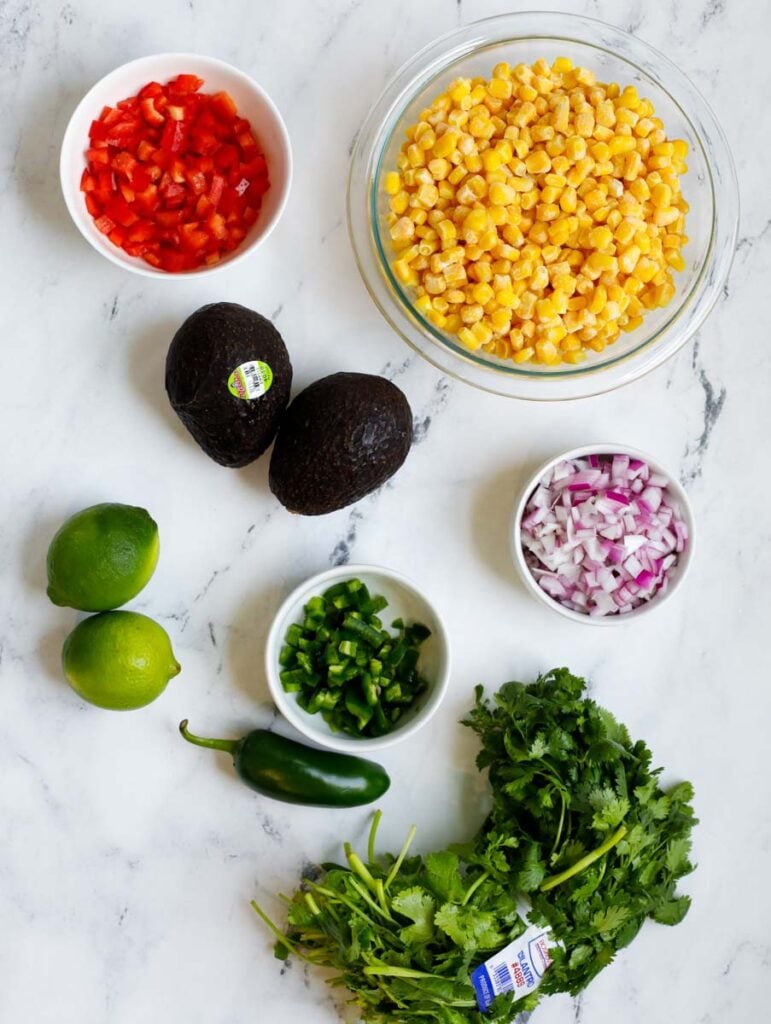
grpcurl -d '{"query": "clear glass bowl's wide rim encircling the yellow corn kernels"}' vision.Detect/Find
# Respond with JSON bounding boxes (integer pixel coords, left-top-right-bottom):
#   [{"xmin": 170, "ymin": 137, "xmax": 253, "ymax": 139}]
[{"xmin": 347, "ymin": 10, "xmax": 739, "ymax": 401}]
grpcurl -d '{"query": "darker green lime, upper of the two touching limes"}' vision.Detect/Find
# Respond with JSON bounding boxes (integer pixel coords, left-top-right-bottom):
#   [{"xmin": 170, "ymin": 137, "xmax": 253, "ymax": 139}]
[{"xmin": 48, "ymin": 504, "xmax": 160, "ymax": 611}]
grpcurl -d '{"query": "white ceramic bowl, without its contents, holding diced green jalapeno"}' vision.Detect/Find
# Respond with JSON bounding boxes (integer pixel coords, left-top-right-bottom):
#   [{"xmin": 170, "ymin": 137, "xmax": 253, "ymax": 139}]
[{"xmin": 265, "ymin": 565, "xmax": 449, "ymax": 755}]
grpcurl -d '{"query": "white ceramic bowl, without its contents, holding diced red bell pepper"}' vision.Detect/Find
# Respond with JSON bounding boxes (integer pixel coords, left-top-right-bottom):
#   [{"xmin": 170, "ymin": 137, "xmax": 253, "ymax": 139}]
[{"xmin": 59, "ymin": 53, "xmax": 292, "ymax": 279}]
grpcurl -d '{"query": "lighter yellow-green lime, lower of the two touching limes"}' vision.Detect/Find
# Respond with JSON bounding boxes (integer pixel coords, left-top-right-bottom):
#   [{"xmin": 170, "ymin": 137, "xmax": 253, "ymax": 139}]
[{"xmin": 61, "ymin": 611, "xmax": 180, "ymax": 711}]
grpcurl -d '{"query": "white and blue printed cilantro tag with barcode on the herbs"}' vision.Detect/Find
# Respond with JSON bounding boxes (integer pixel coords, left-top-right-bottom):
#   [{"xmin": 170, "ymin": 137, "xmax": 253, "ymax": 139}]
[{"xmin": 471, "ymin": 925, "xmax": 557, "ymax": 1013}]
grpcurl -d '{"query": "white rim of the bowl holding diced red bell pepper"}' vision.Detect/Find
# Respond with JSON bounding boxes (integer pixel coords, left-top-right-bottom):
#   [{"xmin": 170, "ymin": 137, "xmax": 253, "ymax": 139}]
[{"xmin": 58, "ymin": 50, "xmax": 294, "ymax": 281}]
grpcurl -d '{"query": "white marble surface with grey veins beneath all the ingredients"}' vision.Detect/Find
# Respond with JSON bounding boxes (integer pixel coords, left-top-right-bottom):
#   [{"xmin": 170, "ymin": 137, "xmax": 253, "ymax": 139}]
[{"xmin": 0, "ymin": 0, "xmax": 771, "ymax": 1024}]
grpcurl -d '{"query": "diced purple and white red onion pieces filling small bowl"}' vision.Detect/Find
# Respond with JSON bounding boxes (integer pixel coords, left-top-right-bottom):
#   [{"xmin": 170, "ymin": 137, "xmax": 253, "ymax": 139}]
[{"xmin": 521, "ymin": 454, "xmax": 688, "ymax": 616}]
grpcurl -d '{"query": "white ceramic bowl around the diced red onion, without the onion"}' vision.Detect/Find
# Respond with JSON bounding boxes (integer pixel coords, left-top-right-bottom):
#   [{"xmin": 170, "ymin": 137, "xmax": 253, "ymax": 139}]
[{"xmin": 510, "ymin": 442, "xmax": 694, "ymax": 626}]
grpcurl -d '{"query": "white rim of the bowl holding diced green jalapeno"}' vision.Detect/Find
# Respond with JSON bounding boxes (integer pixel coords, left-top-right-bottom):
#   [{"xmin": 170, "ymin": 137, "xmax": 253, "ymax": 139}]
[{"xmin": 264, "ymin": 562, "xmax": 452, "ymax": 754}]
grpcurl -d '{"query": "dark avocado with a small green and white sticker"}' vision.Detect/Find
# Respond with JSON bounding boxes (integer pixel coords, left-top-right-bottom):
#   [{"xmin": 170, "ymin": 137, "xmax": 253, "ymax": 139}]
[{"xmin": 166, "ymin": 302, "xmax": 292, "ymax": 467}]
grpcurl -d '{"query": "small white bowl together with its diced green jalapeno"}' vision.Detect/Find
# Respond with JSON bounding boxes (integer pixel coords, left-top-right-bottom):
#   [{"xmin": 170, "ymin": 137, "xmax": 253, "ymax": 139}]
[{"xmin": 265, "ymin": 565, "xmax": 449, "ymax": 753}]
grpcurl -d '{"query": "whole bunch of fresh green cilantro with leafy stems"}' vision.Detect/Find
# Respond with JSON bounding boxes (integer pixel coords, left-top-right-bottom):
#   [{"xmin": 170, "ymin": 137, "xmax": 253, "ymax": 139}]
[{"xmin": 253, "ymin": 669, "xmax": 696, "ymax": 1024}]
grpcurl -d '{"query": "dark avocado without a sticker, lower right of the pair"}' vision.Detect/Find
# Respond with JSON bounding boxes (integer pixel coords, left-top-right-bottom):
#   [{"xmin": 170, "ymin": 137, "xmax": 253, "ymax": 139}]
[{"xmin": 269, "ymin": 373, "xmax": 413, "ymax": 515}]
